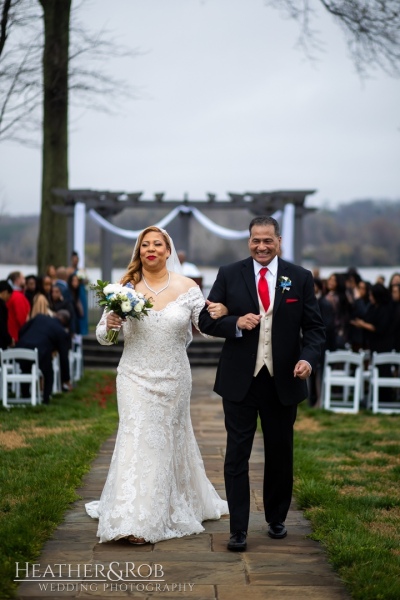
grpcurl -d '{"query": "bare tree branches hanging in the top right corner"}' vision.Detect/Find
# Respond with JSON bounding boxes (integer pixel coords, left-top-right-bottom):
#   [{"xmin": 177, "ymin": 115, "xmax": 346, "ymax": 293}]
[{"xmin": 266, "ymin": 0, "xmax": 400, "ymax": 76}]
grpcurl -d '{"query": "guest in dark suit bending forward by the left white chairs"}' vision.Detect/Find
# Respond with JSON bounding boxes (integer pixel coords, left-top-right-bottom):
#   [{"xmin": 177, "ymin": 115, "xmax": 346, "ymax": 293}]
[{"xmin": 16, "ymin": 310, "xmax": 71, "ymax": 404}]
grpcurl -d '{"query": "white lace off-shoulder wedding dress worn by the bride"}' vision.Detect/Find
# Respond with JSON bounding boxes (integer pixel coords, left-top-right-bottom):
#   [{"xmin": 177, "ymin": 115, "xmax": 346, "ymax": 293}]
[{"xmin": 86, "ymin": 287, "xmax": 228, "ymax": 543}]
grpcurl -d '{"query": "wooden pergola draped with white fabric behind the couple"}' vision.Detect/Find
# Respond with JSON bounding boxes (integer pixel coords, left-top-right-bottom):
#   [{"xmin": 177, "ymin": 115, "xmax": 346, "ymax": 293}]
[{"xmin": 53, "ymin": 189, "xmax": 315, "ymax": 281}]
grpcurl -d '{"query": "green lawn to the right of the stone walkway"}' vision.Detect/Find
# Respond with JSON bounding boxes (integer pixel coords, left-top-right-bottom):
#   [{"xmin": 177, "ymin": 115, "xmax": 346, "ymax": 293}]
[{"xmin": 295, "ymin": 407, "xmax": 400, "ymax": 600}]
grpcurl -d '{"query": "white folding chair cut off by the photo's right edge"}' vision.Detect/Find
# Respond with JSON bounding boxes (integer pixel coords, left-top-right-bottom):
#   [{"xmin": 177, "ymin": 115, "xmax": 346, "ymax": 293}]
[{"xmin": 371, "ymin": 351, "xmax": 400, "ymax": 414}]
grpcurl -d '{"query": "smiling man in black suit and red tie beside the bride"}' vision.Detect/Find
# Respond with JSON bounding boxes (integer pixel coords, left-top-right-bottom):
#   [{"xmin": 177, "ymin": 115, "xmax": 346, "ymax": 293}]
[{"xmin": 199, "ymin": 216, "xmax": 325, "ymax": 551}]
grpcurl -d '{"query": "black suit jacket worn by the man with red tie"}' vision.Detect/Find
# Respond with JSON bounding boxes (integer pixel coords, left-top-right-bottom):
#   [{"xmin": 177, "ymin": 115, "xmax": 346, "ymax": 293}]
[{"xmin": 199, "ymin": 257, "xmax": 325, "ymax": 405}]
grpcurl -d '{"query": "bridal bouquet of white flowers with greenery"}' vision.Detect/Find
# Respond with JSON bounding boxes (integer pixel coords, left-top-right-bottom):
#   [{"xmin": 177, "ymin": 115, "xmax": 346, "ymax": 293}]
[{"xmin": 90, "ymin": 279, "xmax": 153, "ymax": 344}]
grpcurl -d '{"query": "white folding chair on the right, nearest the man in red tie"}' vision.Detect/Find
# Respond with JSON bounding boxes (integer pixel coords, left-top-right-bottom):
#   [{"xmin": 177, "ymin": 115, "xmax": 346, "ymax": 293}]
[{"xmin": 322, "ymin": 350, "xmax": 365, "ymax": 413}]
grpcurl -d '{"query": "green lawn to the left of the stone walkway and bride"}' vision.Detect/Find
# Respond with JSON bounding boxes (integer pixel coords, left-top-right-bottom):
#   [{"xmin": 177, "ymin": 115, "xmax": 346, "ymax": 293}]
[{"xmin": 0, "ymin": 371, "xmax": 118, "ymax": 598}]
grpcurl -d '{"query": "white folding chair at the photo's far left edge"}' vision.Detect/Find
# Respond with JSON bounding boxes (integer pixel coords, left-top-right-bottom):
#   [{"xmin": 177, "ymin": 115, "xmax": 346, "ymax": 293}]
[{"xmin": 0, "ymin": 348, "xmax": 42, "ymax": 408}]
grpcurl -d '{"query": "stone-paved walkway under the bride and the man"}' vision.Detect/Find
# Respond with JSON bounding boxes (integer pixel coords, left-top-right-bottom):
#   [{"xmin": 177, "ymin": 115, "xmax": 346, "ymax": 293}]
[{"xmin": 17, "ymin": 368, "xmax": 349, "ymax": 600}]
